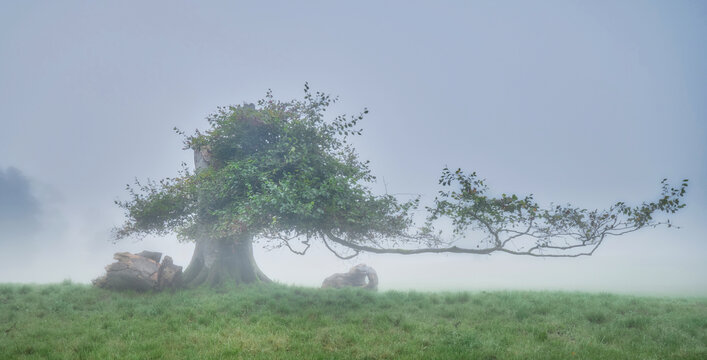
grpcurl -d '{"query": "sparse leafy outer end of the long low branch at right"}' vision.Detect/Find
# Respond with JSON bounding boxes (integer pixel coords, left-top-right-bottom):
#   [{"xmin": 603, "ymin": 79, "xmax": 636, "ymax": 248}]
[{"xmin": 425, "ymin": 167, "xmax": 688, "ymax": 256}]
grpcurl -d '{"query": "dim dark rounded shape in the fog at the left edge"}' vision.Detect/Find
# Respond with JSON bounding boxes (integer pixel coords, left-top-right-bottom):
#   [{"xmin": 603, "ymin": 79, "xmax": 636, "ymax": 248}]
[{"xmin": 0, "ymin": 167, "xmax": 41, "ymax": 241}]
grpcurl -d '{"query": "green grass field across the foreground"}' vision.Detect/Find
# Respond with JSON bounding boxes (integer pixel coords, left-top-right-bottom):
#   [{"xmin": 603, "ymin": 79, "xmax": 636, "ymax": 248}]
[{"xmin": 0, "ymin": 283, "xmax": 707, "ymax": 359}]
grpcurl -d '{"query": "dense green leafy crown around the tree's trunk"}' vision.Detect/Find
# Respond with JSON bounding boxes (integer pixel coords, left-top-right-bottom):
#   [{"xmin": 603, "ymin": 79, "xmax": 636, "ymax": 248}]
[{"xmin": 116, "ymin": 87, "xmax": 416, "ymax": 248}]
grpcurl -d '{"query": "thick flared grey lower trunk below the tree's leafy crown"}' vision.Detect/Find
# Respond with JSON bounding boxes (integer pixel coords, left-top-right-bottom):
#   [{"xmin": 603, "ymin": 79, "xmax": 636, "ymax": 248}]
[{"xmin": 182, "ymin": 235, "xmax": 271, "ymax": 287}]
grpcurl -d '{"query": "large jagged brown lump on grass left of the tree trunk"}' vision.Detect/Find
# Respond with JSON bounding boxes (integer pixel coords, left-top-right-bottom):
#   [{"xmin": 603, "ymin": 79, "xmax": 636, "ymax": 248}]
[{"xmin": 93, "ymin": 251, "xmax": 182, "ymax": 291}]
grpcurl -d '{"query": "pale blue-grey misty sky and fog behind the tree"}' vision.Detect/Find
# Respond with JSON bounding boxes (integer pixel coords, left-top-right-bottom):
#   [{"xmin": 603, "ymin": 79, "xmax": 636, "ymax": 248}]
[{"xmin": 0, "ymin": 1, "xmax": 707, "ymax": 295}]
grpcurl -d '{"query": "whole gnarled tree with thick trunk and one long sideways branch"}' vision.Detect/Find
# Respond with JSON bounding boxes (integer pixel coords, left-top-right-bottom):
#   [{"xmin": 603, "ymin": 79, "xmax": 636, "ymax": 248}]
[{"xmin": 115, "ymin": 84, "xmax": 687, "ymax": 286}]
